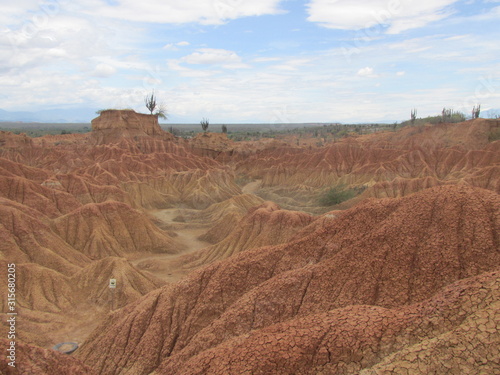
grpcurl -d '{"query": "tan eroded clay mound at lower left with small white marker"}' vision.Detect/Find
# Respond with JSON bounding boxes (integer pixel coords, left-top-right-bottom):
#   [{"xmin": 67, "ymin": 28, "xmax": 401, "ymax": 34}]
[{"xmin": 0, "ymin": 257, "xmax": 164, "ymax": 348}]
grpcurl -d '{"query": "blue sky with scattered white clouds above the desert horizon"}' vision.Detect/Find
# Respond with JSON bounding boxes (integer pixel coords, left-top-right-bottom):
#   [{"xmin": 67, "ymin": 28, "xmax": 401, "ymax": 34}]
[{"xmin": 0, "ymin": 0, "xmax": 500, "ymax": 123}]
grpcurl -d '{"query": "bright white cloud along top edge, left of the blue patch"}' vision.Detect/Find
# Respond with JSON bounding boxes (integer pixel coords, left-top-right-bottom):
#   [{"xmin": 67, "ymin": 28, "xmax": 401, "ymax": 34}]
[{"xmin": 80, "ymin": 0, "xmax": 282, "ymax": 25}]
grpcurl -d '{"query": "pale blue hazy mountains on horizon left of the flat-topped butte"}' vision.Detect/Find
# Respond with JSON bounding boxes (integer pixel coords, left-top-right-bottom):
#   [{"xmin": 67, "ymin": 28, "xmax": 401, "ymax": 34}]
[{"xmin": 0, "ymin": 108, "xmax": 97, "ymax": 123}]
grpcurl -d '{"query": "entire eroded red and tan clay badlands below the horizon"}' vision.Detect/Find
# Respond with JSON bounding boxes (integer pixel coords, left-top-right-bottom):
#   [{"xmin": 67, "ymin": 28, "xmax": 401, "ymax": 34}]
[{"xmin": 0, "ymin": 110, "xmax": 500, "ymax": 375}]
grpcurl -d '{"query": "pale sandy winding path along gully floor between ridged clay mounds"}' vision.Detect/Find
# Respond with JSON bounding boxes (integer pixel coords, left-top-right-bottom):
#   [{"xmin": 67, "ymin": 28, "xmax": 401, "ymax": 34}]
[{"xmin": 130, "ymin": 208, "xmax": 211, "ymax": 283}]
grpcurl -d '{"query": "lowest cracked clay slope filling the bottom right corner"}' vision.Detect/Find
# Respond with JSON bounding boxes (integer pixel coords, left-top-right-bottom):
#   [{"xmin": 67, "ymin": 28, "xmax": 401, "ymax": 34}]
[{"xmin": 160, "ymin": 272, "xmax": 500, "ymax": 375}]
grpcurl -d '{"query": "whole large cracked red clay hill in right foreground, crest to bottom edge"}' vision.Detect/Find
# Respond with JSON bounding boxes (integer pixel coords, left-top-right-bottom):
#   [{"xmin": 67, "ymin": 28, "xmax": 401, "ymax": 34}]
[{"xmin": 76, "ymin": 186, "xmax": 500, "ymax": 374}]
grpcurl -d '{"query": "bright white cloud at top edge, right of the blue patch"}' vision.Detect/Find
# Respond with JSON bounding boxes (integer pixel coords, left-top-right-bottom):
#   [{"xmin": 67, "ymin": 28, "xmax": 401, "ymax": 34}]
[{"xmin": 307, "ymin": 0, "xmax": 457, "ymax": 34}]
